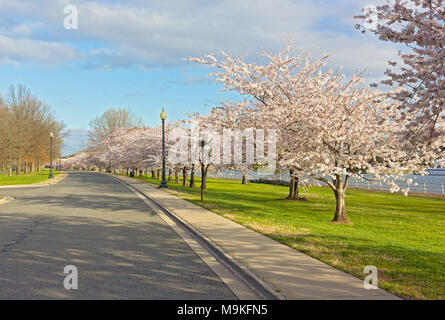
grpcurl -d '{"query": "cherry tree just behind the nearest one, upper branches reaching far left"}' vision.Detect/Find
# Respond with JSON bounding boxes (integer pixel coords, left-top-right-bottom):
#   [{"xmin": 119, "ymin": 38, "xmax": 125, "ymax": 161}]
[{"xmin": 188, "ymin": 42, "xmax": 328, "ymax": 200}]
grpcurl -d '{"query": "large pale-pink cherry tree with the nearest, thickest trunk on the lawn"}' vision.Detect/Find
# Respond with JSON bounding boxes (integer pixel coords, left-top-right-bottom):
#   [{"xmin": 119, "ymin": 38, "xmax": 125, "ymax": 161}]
[{"xmin": 190, "ymin": 45, "xmax": 436, "ymax": 223}]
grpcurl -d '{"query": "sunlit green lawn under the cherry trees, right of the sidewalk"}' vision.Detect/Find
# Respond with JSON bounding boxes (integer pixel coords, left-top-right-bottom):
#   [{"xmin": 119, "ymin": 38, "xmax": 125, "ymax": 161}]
[{"xmin": 129, "ymin": 172, "xmax": 445, "ymax": 299}]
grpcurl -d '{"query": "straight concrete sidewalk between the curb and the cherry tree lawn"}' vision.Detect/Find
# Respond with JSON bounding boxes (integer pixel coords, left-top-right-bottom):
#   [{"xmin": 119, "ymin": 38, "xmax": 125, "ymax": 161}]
[{"xmin": 117, "ymin": 172, "xmax": 400, "ymax": 300}]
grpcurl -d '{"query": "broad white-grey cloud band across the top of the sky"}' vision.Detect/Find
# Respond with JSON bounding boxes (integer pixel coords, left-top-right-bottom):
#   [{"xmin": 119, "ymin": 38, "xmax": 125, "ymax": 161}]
[{"xmin": 0, "ymin": 0, "xmax": 395, "ymax": 77}]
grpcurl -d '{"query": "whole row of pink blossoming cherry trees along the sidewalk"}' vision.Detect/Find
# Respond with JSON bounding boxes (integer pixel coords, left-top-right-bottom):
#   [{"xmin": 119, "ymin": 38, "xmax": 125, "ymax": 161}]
[{"xmin": 64, "ymin": 1, "xmax": 445, "ymax": 223}]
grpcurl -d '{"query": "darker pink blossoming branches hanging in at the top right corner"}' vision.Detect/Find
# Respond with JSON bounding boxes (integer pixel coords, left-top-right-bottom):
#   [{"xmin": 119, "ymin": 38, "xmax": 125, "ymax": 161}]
[{"xmin": 355, "ymin": 0, "xmax": 445, "ymax": 142}]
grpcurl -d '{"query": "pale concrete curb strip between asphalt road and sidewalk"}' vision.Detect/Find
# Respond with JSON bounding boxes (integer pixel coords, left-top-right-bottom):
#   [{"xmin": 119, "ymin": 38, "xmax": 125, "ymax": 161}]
[{"xmin": 111, "ymin": 176, "xmax": 288, "ymax": 300}]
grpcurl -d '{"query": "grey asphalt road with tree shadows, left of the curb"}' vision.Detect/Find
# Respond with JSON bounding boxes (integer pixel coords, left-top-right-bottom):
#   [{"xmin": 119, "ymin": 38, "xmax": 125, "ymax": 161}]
[{"xmin": 0, "ymin": 172, "xmax": 235, "ymax": 299}]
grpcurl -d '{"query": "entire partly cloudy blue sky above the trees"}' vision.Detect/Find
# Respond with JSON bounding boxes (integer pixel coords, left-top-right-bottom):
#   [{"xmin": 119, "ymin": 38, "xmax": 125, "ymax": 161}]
[{"xmin": 0, "ymin": 0, "xmax": 396, "ymax": 153}]
